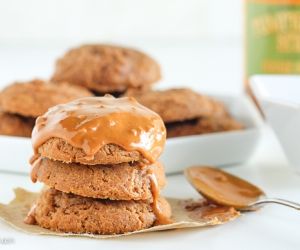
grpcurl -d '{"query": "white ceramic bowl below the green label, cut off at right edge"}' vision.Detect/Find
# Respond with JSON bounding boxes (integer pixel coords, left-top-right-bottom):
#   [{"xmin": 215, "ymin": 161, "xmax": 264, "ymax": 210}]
[{"xmin": 250, "ymin": 75, "xmax": 300, "ymax": 168}]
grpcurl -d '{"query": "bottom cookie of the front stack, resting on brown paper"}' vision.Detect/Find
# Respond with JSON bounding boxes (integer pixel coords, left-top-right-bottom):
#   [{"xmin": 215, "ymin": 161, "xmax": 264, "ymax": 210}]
[{"xmin": 25, "ymin": 189, "xmax": 171, "ymax": 234}]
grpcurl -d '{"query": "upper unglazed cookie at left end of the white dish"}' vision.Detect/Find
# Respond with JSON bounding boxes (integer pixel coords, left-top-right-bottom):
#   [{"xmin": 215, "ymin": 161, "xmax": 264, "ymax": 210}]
[{"xmin": 0, "ymin": 80, "xmax": 92, "ymax": 117}]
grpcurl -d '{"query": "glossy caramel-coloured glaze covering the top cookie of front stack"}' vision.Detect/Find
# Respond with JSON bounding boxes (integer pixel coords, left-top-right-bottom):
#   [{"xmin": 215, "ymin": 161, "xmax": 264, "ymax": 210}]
[{"xmin": 32, "ymin": 95, "xmax": 166, "ymax": 163}]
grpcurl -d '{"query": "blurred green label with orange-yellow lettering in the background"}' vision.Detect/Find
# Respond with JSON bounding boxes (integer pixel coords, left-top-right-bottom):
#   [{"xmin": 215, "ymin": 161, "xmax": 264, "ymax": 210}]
[{"xmin": 246, "ymin": 3, "xmax": 300, "ymax": 76}]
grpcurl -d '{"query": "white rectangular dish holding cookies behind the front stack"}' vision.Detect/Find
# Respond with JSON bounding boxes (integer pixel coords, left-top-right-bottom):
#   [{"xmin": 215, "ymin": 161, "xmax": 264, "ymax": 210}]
[{"xmin": 0, "ymin": 96, "xmax": 262, "ymax": 173}]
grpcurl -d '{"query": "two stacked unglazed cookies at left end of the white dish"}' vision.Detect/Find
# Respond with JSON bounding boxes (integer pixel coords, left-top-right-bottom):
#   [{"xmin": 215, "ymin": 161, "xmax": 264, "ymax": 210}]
[{"xmin": 0, "ymin": 80, "xmax": 92, "ymax": 137}]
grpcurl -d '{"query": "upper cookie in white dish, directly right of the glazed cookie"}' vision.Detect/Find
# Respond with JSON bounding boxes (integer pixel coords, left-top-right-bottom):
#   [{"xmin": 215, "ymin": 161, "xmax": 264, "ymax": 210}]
[{"xmin": 133, "ymin": 88, "xmax": 228, "ymax": 123}]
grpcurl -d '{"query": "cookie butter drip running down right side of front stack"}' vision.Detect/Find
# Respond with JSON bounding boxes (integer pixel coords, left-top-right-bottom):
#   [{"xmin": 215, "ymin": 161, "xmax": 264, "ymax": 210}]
[{"xmin": 147, "ymin": 165, "xmax": 172, "ymax": 225}]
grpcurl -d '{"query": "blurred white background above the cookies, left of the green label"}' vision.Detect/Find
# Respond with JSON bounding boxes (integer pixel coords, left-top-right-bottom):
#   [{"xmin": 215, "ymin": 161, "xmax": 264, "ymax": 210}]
[{"xmin": 0, "ymin": 0, "xmax": 243, "ymax": 93}]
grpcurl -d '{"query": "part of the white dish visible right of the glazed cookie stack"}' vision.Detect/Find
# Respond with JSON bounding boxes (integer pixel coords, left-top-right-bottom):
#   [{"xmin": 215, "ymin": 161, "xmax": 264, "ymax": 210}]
[{"xmin": 161, "ymin": 96, "xmax": 263, "ymax": 173}]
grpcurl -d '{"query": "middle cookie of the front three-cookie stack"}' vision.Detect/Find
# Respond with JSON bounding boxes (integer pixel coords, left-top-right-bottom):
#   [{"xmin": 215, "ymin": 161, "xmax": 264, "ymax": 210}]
[{"xmin": 31, "ymin": 158, "xmax": 166, "ymax": 200}]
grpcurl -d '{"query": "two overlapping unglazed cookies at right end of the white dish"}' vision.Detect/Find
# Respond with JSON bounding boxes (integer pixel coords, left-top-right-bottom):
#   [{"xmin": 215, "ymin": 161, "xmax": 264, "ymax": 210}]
[{"xmin": 132, "ymin": 88, "xmax": 244, "ymax": 138}]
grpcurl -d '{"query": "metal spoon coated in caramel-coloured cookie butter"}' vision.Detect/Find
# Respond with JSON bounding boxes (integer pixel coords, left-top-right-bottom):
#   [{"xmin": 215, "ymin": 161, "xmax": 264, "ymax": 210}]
[{"xmin": 184, "ymin": 166, "xmax": 300, "ymax": 211}]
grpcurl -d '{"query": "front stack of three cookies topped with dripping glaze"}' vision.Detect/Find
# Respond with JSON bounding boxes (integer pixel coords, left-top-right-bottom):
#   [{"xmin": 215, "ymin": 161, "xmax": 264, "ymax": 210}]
[{"xmin": 25, "ymin": 96, "xmax": 171, "ymax": 234}]
